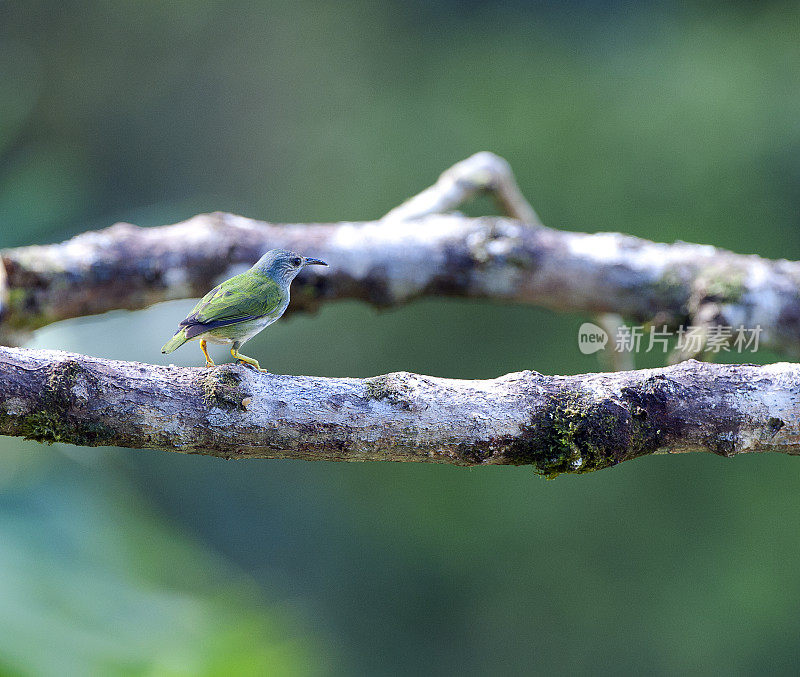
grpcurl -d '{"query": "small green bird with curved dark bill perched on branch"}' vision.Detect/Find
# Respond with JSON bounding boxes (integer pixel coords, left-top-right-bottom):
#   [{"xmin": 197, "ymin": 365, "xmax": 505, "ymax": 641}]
[{"xmin": 161, "ymin": 249, "xmax": 328, "ymax": 372}]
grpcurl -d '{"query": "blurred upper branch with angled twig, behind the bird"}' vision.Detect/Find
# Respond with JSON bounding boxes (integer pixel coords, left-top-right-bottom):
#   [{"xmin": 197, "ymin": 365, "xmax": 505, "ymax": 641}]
[{"xmin": 0, "ymin": 153, "xmax": 800, "ymax": 356}]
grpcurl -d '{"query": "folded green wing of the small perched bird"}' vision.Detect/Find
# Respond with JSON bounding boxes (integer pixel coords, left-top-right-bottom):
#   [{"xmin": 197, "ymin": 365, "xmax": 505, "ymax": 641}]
[{"xmin": 180, "ymin": 271, "xmax": 285, "ymax": 338}]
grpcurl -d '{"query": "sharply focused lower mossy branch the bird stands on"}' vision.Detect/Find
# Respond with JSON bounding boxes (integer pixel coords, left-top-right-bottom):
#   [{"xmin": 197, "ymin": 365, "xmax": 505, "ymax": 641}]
[{"xmin": 0, "ymin": 348, "xmax": 800, "ymax": 476}]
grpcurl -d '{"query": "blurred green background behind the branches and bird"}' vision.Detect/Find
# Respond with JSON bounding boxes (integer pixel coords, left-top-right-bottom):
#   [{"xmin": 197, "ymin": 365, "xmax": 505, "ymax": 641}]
[{"xmin": 0, "ymin": 0, "xmax": 800, "ymax": 675}]
